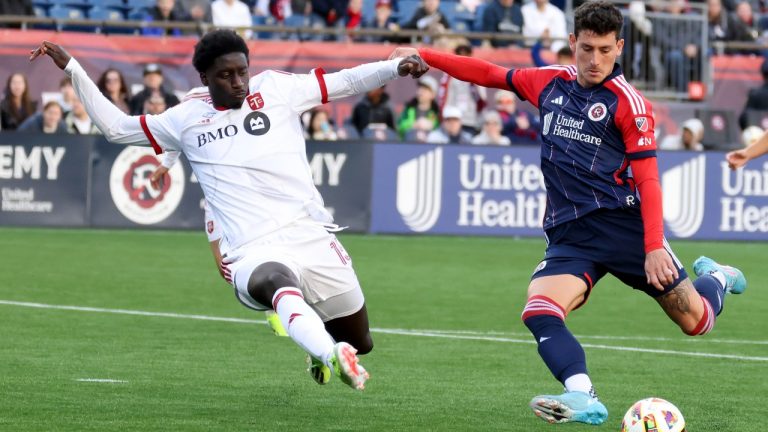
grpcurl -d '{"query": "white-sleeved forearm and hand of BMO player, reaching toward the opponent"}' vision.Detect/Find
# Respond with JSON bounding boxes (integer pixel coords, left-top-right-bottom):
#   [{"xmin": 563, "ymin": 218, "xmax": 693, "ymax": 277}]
[{"xmin": 324, "ymin": 55, "xmax": 429, "ymax": 101}]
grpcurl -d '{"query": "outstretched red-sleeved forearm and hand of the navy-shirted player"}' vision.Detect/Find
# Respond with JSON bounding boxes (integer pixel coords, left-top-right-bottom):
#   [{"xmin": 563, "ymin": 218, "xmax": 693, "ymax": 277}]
[{"xmin": 389, "ymin": 47, "xmax": 509, "ymax": 90}]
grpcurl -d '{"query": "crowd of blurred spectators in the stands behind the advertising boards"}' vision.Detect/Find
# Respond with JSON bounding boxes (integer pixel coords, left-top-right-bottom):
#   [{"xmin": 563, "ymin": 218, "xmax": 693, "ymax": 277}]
[{"xmin": 0, "ymin": 0, "xmax": 768, "ymax": 150}]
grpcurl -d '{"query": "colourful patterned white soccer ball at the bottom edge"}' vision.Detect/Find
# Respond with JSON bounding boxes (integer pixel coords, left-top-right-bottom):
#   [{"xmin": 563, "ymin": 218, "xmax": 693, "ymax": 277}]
[{"xmin": 621, "ymin": 398, "xmax": 685, "ymax": 432}]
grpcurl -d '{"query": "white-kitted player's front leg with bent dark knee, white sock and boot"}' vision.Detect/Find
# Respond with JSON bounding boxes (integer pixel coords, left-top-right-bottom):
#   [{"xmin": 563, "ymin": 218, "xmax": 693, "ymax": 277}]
[{"xmin": 248, "ymin": 262, "xmax": 367, "ymax": 390}]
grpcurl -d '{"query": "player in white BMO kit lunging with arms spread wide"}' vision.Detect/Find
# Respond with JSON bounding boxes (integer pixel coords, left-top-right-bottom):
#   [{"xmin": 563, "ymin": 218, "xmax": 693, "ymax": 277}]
[{"xmin": 30, "ymin": 30, "xmax": 428, "ymax": 390}]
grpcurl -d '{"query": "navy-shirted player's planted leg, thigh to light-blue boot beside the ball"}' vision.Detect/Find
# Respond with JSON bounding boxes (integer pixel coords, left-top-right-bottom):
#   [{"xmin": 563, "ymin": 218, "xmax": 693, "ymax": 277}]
[{"xmin": 522, "ymin": 275, "xmax": 608, "ymax": 425}]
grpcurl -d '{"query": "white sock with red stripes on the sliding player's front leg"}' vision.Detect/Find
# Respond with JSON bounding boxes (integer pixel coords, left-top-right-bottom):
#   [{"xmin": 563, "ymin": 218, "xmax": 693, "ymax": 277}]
[{"xmin": 272, "ymin": 287, "xmax": 334, "ymax": 364}]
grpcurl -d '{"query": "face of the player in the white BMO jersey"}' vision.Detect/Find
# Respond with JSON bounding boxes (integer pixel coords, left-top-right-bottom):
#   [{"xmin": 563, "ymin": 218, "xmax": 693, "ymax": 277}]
[{"xmin": 201, "ymin": 52, "xmax": 249, "ymax": 109}]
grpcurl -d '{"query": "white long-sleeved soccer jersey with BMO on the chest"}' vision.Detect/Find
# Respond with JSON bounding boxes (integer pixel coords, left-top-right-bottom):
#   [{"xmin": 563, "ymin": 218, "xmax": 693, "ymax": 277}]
[{"xmin": 65, "ymin": 59, "xmax": 399, "ymax": 253}]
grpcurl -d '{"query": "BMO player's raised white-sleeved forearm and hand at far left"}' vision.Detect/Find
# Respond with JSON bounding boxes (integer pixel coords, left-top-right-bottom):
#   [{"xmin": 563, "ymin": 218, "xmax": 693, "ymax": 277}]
[{"xmin": 29, "ymin": 41, "xmax": 149, "ymax": 146}]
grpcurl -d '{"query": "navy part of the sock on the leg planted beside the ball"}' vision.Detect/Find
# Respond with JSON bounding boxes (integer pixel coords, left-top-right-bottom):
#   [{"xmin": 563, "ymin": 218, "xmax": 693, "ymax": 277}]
[{"xmin": 523, "ymin": 315, "xmax": 587, "ymax": 383}]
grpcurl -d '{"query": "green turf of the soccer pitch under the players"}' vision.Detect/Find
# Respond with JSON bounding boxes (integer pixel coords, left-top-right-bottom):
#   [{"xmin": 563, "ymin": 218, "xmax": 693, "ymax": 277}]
[{"xmin": 0, "ymin": 228, "xmax": 768, "ymax": 432}]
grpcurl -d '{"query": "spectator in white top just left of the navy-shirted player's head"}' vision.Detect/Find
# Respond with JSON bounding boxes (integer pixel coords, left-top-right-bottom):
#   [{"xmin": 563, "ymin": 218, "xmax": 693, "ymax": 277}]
[{"xmin": 521, "ymin": 0, "xmax": 568, "ymax": 52}]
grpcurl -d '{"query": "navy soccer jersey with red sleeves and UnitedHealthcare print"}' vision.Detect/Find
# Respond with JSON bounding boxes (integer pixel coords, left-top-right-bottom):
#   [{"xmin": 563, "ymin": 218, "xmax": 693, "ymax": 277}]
[{"xmin": 507, "ymin": 65, "xmax": 656, "ymax": 230}]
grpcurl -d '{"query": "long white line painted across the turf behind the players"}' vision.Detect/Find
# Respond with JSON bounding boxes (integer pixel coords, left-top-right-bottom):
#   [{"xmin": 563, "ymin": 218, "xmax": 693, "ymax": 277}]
[{"xmin": 0, "ymin": 300, "xmax": 768, "ymax": 362}]
